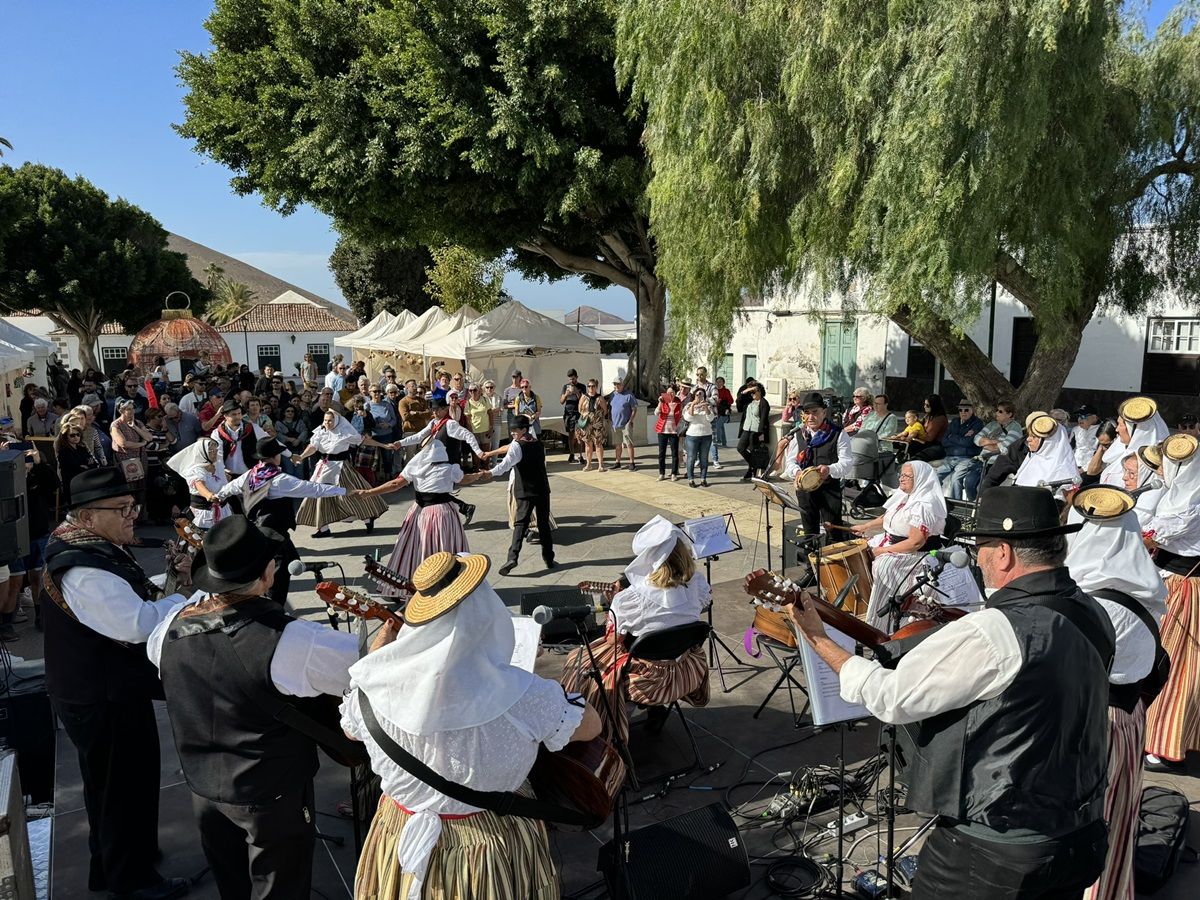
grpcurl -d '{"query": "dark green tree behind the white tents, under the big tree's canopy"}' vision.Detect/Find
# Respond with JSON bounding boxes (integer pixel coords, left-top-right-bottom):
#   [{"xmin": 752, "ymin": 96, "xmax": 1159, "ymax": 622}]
[{"xmin": 329, "ymin": 235, "xmax": 433, "ymax": 323}]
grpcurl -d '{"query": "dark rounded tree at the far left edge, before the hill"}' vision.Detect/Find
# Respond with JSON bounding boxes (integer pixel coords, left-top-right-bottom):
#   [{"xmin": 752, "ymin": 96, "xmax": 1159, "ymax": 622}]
[{"xmin": 0, "ymin": 163, "xmax": 209, "ymax": 368}]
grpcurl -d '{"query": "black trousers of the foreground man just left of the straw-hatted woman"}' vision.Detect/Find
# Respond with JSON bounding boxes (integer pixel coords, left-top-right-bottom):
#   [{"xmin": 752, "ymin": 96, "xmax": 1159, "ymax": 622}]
[{"xmin": 192, "ymin": 779, "xmax": 317, "ymax": 900}]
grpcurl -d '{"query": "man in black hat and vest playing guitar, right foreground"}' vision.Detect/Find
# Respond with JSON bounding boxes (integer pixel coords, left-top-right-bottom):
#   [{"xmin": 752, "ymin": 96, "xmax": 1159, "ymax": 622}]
[{"xmin": 791, "ymin": 487, "xmax": 1116, "ymax": 900}]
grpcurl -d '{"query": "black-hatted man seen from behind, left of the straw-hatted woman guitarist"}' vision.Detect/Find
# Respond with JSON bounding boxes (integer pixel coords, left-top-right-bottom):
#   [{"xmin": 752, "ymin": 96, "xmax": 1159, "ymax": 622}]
[{"xmin": 146, "ymin": 516, "xmax": 359, "ymax": 900}]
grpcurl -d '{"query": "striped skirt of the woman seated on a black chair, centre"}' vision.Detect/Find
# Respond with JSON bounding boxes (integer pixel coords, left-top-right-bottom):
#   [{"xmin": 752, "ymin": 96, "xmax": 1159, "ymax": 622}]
[{"xmin": 558, "ymin": 625, "xmax": 708, "ymax": 742}]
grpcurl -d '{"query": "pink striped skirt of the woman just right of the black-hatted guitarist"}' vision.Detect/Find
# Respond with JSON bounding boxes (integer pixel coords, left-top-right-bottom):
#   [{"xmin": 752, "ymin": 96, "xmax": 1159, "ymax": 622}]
[{"xmin": 1084, "ymin": 703, "xmax": 1146, "ymax": 900}]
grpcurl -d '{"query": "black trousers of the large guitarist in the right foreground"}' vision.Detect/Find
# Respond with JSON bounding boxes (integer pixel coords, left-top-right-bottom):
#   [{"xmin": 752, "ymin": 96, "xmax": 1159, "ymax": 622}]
[{"xmin": 912, "ymin": 821, "xmax": 1109, "ymax": 900}]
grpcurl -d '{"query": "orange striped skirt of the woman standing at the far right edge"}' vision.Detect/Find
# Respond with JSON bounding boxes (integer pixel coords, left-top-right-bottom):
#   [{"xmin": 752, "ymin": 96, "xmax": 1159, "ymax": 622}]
[{"xmin": 1146, "ymin": 575, "xmax": 1200, "ymax": 762}]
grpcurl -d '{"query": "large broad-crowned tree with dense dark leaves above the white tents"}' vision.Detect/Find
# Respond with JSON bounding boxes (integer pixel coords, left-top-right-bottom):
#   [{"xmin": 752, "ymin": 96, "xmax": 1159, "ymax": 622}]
[{"xmin": 179, "ymin": 0, "xmax": 666, "ymax": 385}]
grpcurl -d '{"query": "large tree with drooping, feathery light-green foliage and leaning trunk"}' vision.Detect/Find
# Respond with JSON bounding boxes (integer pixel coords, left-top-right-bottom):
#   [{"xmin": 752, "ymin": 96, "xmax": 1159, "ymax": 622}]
[{"xmin": 618, "ymin": 0, "xmax": 1200, "ymax": 409}]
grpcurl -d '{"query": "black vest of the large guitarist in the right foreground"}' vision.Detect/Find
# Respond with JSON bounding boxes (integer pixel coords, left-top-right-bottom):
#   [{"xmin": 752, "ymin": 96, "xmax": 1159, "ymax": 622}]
[{"xmin": 901, "ymin": 568, "xmax": 1116, "ymax": 834}]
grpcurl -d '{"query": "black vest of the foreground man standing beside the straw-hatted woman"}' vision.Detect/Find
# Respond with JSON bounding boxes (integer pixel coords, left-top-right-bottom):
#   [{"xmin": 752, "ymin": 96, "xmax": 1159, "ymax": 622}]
[{"xmin": 158, "ymin": 598, "xmax": 328, "ymax": 803}]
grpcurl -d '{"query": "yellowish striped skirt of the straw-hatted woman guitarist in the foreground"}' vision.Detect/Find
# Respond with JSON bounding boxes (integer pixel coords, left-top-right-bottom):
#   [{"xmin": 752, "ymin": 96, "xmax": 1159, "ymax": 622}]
[{"xmin": 354, "ymin": 788, "xmax": 559, "ymax": 900}]
